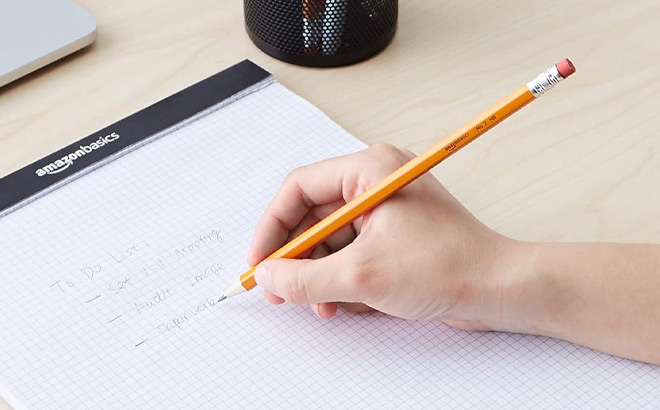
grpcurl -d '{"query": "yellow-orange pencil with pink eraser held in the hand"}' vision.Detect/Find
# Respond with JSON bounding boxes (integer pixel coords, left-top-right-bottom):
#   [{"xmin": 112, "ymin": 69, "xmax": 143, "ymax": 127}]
[{"xmin": 219, "ymin": 59, "xmax": 575, "ymax": 301}]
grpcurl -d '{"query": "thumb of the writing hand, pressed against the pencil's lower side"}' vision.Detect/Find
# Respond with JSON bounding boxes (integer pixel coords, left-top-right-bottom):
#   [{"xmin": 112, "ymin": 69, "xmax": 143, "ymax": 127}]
[{"xmin": 254, "ymin": 249, "xmax": 357, "ymax": 305}]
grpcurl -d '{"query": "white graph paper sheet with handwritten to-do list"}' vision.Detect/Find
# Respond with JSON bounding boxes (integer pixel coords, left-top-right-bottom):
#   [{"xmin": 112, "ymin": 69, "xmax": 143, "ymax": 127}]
[{"xmin": 0, "ymin": 61, "xmax": 660, "ymax": 410}]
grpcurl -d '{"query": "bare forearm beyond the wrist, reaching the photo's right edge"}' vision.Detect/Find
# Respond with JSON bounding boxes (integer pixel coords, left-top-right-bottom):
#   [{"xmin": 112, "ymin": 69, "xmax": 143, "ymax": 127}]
[{"xmin": 503, "ymin": 243, "xmax": 660, "ymax": 364}]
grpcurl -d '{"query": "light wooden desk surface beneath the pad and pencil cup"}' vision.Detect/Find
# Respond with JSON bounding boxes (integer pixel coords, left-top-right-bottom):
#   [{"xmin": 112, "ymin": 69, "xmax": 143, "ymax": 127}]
[{"xmin": 0, "ymin": 0, "xmax": 660, "ymax": 409}]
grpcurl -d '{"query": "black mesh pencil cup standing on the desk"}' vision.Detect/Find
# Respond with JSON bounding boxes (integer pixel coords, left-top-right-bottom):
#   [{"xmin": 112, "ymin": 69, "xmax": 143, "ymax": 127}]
[{"xmin": 244, "ymin": 0, "xmax": 399, "ymax": 67}]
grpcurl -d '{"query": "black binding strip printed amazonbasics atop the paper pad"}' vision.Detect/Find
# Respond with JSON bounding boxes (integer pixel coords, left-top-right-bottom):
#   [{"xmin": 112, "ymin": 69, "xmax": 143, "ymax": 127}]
[{"xmin": 0, "ymin": 60, "xmax": 270, "ymax": 213}]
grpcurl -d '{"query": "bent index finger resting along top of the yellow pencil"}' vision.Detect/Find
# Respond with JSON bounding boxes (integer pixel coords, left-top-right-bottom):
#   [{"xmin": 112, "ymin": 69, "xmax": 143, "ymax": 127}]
[{"xmin": 247, "ymin": 154, "xmax": 359, "ymax": 266}]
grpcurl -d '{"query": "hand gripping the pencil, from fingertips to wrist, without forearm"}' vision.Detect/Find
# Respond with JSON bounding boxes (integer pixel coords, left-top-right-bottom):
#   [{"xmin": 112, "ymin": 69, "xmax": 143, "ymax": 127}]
[{"xmin": 248, "ymin": 144, "xmax": 513, "ymax": 330}]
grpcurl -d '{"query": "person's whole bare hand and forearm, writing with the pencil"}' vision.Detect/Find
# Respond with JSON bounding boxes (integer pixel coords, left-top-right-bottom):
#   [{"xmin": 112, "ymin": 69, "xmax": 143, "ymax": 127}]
[{"xmin": 248, "ymin": 145, "xmax": 660, "ymax": 364}]
